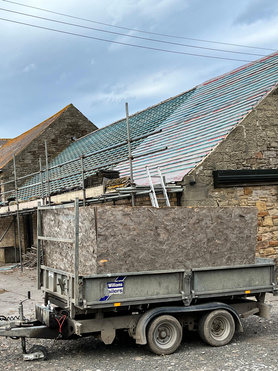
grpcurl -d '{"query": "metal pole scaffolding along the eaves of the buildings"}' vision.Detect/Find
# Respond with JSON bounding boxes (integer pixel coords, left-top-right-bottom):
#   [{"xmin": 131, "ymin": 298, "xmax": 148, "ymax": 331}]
[{"xmin": 0, "ymin": 109, "xmax": 183, "ymax": 269}]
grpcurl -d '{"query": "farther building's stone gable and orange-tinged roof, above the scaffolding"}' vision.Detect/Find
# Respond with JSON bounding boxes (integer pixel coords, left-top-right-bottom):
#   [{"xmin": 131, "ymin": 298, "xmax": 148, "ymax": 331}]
[{"xmin": 0, "ymin": 104, "xmax": 97, "ymax": 199}]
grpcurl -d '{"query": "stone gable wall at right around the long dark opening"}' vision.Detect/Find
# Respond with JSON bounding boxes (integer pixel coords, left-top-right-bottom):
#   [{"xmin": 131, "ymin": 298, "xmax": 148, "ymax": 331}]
[{"xmin": 182, "ymin": 89, "xmax": 278, "ymax": 260}]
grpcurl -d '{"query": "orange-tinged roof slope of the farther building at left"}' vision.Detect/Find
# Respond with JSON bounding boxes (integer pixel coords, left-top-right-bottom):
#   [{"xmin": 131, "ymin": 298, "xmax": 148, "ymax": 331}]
[{"xmin": 0, "ymin": 106, "xmax": 69, "ymax": 169}]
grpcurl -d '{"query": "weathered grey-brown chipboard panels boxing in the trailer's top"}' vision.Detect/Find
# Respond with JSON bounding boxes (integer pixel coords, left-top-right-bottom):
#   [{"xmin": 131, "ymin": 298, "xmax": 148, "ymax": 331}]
[{"xmin": 43, "ymin": 206, "xmax": 257, "ymax": 275}]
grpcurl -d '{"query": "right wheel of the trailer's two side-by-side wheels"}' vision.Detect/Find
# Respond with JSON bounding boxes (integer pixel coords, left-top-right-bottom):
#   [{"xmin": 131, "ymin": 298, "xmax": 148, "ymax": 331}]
[{"xmin": 198, "ymin": 310, "xmax": 235, "ymax": 347}]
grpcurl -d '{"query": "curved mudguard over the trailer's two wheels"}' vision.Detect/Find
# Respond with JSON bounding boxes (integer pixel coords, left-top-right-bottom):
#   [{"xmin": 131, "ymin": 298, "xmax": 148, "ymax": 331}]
[{"xmin": 135, "ymin": 302, "xmax": 243, "ymax": 345}]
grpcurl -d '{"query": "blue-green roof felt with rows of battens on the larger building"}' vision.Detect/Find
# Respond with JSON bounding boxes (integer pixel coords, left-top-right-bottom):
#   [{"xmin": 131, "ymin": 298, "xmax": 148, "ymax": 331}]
[{"xmin": 19, "ymin": 52, "xmax": 278, "ymax": 201}]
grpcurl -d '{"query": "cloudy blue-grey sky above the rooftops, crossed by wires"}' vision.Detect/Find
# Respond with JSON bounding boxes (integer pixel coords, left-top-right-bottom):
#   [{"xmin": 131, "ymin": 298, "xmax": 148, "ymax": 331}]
[{"xmin": 0, "ymin": 0, "xmax": 278, "ymax": 138}]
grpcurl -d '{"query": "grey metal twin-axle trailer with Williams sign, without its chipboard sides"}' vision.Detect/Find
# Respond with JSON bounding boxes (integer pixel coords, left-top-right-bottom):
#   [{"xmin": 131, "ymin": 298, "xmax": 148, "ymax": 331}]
[{"xmin": 0, "ymin": 200, "xmax": 278, "ymax": 359}]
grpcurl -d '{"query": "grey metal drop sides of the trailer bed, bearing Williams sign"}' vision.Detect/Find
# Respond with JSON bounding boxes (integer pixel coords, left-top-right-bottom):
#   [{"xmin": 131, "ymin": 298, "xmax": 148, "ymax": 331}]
[{"xmin": 41, "ymin": 258, "xmax": 277, "ymax": 310}]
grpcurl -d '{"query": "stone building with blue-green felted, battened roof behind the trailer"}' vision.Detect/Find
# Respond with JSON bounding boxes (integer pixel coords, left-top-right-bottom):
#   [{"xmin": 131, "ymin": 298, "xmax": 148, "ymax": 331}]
[{"xmin": 1, "ymin": 52, "xmax": 278, "ymax": 264}]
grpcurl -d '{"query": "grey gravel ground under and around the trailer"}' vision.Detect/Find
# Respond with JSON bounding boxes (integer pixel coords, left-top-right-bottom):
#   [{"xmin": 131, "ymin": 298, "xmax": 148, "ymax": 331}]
[{"xmin": 0, "ymin": 269, "xmax": 278, "ymax": 371}]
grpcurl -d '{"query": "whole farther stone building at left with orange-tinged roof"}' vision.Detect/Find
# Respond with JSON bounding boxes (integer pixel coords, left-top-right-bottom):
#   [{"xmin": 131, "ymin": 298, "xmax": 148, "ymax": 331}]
[{"xmin": 0, "ymin": 104, "xmax": 97, "ymax": 262}]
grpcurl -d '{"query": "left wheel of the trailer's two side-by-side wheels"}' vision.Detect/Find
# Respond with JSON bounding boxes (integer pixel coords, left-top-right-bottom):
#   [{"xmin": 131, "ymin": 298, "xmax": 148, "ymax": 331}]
[{"xmin": 147, "ymin": 315, "xmax": 182, "ymax": 355}]
